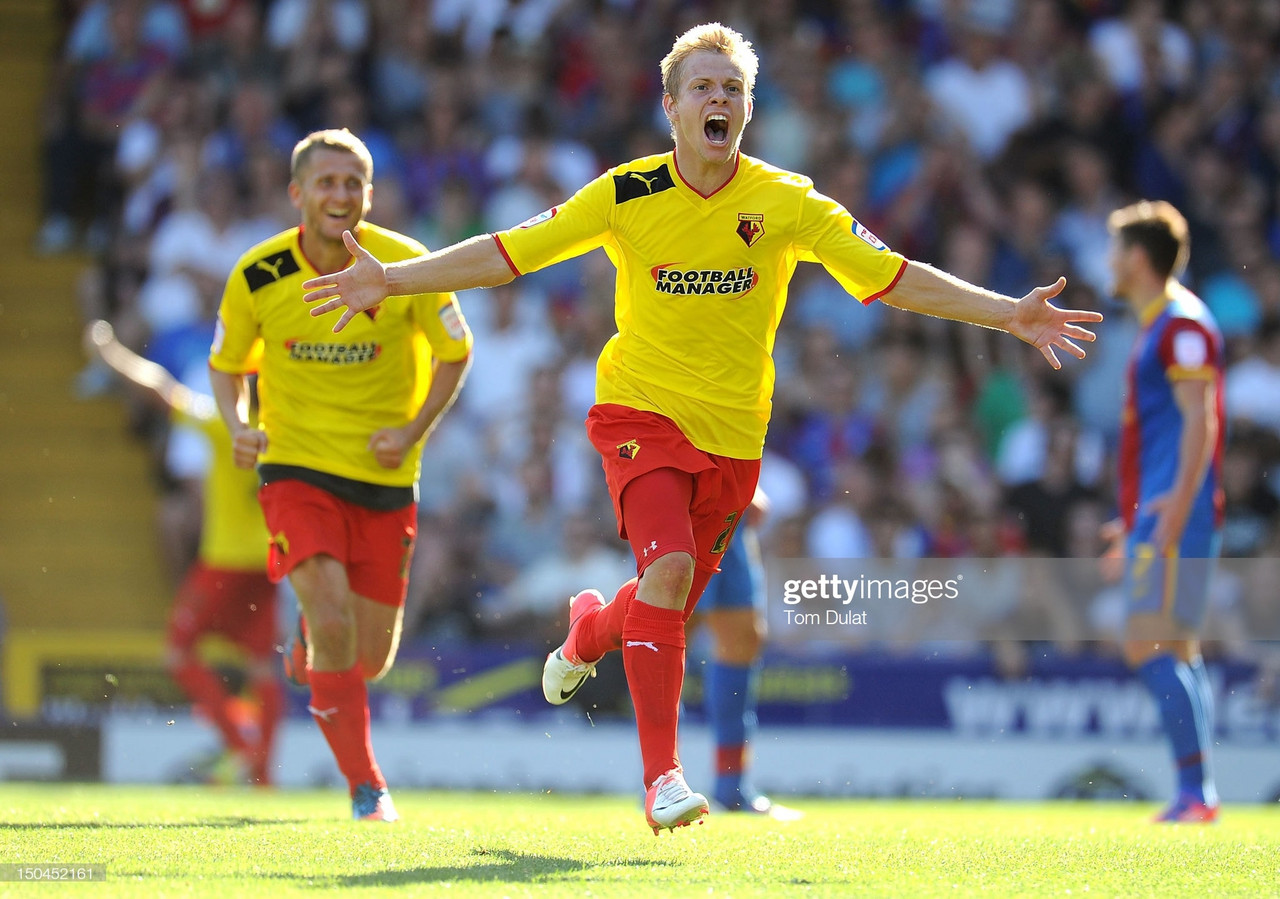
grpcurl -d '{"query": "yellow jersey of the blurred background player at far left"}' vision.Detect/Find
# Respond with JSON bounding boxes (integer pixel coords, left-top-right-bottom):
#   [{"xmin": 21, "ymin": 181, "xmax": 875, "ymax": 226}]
[{"xmin": 173, "ymin": 409, "xmax": 269, "ymax": 571}]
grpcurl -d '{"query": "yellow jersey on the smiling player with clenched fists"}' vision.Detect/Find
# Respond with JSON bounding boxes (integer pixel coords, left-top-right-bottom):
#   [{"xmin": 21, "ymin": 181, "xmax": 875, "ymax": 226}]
[{"xmin": 209, "ymin": 223, "xmax": 471, "ymax": 487}]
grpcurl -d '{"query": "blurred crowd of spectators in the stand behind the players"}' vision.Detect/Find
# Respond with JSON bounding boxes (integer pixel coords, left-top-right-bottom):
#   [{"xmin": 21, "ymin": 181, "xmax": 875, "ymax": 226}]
[{"xmin": 38, "ymin": 0, "xmax": 1280, "ymax": 671}]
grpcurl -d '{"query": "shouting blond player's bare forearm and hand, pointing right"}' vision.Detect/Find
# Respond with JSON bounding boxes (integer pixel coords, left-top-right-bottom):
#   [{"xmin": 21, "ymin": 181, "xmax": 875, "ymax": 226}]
[{"xmin": 882, "ymin": 263, "xmax": 1102, "ymax": 369}]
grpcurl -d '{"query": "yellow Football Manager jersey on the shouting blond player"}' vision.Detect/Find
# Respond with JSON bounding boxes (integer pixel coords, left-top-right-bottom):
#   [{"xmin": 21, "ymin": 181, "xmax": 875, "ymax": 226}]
[{"xmin": 494, "ymin": 152, "xmax": 906, "ymax": 458}]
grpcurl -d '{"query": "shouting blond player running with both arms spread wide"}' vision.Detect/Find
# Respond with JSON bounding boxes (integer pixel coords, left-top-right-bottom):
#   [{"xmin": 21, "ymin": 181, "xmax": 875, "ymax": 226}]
[{"xmin": 303, "ymin": 23, "xmax": 1101, "ymax": 832}]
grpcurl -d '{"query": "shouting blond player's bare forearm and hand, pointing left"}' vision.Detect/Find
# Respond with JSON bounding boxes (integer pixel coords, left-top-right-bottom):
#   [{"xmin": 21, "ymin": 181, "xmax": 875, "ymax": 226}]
[{"xmin": 302, "ymin": 231, "xmax": 516, "ymax": 332}]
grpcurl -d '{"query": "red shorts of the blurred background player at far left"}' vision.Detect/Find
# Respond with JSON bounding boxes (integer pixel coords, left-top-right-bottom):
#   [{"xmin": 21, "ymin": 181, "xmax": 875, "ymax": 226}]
[{"xmin": 169, "ymin": 561, "xmax": 275, "ymax": 658}]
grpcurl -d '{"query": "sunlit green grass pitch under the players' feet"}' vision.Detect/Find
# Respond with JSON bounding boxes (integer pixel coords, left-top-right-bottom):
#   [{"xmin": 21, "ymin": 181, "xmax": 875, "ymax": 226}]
[{"xmin": 0, "ymin": 784, "xmax": 1280, "ymax": 899}]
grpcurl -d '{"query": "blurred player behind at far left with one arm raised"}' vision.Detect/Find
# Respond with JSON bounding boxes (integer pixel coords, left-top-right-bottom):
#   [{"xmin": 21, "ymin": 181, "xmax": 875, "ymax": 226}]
[{"xmin": 84, "ymin": 321, "xmax": 284, "ymax": 786}]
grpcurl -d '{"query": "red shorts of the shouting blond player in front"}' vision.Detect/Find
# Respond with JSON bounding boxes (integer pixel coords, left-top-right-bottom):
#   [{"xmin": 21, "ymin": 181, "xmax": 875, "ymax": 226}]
[{"xmin": 586, "ymin": 403, "xmax": 760, "ymax": 574}]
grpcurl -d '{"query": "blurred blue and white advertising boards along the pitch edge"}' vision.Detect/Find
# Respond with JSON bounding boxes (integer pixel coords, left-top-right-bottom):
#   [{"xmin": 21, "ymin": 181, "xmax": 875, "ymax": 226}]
[{"xmin": 0, "ymin": 648, "xmax": 1280, "ymax": 802}]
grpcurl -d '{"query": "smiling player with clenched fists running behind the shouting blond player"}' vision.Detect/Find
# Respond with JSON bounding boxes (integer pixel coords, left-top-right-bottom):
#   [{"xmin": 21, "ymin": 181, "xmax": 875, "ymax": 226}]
[{"xmin": 209, "ymin": 131, "xmax": 471, "ymax": 821}]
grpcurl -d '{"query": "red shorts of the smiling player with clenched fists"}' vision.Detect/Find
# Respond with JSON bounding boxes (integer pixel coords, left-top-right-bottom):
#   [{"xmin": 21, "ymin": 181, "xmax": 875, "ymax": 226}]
[{"xmin": 257, "ymin": 480, "xmax": 417, "ymax": 606}]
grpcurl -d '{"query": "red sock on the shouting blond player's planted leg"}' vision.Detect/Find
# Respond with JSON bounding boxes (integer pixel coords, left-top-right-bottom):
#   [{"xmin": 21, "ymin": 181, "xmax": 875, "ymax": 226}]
[{"xmin": 622, "ymin": 599, "xmax": 685, "ymax": 789}]
